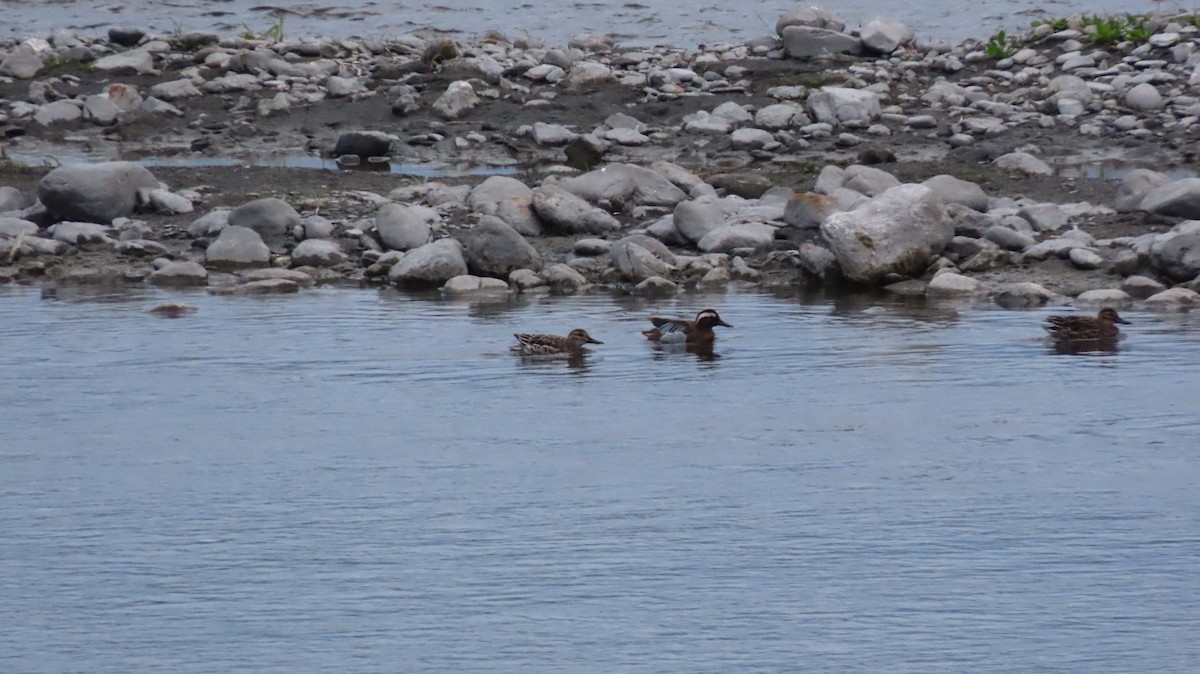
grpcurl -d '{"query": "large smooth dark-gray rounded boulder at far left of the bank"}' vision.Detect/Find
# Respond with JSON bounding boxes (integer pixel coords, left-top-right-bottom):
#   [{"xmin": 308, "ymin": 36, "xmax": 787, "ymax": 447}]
[{"xmin": 37, "ymin": 162, "xmax": 158, "ymax": 224}]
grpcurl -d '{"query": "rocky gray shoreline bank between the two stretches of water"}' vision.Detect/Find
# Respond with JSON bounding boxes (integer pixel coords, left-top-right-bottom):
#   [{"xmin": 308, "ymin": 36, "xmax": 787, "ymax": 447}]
[{"xmin": 0, "ymin": 7, "xmax": 1200, "ymax": 309}]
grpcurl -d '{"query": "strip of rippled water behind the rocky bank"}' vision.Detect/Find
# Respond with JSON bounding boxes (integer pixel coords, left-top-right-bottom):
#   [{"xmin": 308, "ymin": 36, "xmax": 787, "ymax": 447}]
[{"xmin": 0, "ymin": 0, "xmax": 1176, "ymax": 47}]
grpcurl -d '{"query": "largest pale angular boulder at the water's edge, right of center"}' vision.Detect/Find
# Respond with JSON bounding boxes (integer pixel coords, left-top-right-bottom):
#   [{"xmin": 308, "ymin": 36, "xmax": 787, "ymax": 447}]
[{"xmin": 821, "ymin": 185, "xmax": 954, "ymax": 283}]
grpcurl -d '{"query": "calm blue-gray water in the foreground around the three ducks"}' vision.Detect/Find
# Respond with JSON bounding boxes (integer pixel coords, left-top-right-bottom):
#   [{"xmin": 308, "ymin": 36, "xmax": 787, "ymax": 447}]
[{"xmin": 0, "ymin": 287, "xmax": 1200, "ymax": 674}]
